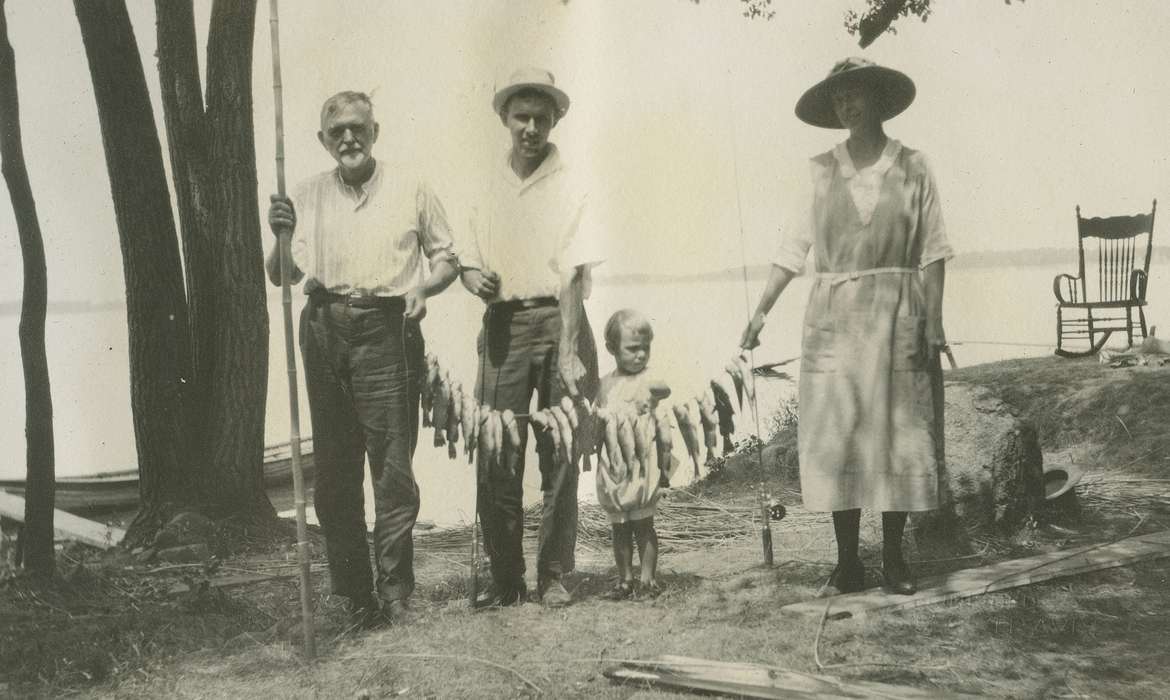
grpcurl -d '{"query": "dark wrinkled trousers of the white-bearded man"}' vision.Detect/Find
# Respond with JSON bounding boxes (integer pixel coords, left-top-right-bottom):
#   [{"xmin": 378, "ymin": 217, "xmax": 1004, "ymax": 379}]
[{"xmin": 301, "ymin": 300, "xmax": 424, "ymax": 601}]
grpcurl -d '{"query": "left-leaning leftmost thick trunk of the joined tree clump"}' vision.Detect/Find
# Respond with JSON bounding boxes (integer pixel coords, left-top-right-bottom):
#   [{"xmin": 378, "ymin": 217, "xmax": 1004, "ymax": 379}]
[{"xmin": 74, "ymin": 0, "xmax": 204, "ymax": 543}]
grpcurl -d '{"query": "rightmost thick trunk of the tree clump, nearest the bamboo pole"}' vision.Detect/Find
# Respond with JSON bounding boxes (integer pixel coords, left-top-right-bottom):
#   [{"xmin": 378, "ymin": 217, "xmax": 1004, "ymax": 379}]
[{"xmin": 204, "ymin": 0, "xmax": 275, "ymax": 514}]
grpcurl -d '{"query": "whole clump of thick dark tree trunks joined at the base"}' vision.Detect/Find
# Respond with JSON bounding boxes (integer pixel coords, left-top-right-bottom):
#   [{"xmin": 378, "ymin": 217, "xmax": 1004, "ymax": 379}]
[{"xmin": 74, "ymin": 0, "xmax": 274, "ymax": 543}]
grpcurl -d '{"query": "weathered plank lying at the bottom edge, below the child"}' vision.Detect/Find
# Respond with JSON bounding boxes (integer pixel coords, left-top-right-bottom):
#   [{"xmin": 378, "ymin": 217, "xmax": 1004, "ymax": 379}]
[{"xmin": 605, "ymin": 654, "xmax": 961, "ymax": 700}]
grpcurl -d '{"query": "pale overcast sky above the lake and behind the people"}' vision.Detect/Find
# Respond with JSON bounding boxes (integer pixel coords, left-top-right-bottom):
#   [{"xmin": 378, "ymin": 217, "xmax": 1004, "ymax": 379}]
[{"xmin": 0, "ymin": 0, "xmax": 1170, "ymax": 300}]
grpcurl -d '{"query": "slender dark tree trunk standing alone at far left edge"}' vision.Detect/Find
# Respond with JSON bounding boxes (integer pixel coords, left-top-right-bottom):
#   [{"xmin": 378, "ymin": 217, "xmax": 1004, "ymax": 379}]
[{"xmin": 0, "ymin": 0, "xmax": 55, "ymax": 575}]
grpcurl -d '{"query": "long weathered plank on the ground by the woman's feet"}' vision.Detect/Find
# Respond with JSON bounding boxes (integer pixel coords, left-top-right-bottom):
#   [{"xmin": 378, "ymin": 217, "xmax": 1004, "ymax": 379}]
[{"xmin": 780, "ymin": 530, "xmax": 1170, "ymax": 618}]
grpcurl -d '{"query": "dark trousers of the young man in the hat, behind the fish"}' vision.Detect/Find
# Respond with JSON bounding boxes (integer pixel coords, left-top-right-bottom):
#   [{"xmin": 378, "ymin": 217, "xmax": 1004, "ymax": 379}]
[{"xmin": 475, "ymin": 306, "xmax": 598, "ymax": 588}]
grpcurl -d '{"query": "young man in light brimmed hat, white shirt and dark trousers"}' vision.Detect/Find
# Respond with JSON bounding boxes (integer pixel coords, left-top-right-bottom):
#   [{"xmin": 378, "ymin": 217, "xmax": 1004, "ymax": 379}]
[{"xmin": 461, "ymin": 68, "xmax": 601, "ymax": 606}]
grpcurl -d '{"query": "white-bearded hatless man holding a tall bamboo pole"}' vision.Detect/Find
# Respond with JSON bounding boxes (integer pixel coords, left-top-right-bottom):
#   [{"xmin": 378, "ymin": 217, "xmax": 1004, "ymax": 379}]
[{"xmin": 267, "ymin": 91, "xmax": 457, "ymax": 625}]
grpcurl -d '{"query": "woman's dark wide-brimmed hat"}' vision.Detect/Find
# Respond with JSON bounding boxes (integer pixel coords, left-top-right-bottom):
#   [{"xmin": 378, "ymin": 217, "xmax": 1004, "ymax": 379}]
[{"xmin": 797, "ymin": 57, "xmax": 915, "ymax": 129}]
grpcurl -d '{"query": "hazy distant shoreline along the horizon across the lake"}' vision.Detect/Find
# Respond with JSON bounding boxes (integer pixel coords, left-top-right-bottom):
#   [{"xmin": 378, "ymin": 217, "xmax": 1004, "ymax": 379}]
[{"xmin": 0, "ymin": 246, "xmax": 1170, "ymax": 316}]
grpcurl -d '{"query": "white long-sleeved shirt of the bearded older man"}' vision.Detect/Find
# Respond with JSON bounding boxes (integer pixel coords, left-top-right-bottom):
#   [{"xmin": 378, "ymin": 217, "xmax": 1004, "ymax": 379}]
[{"xmin": 291, "ymin": 160, "xmax": 454, "ymax": 296}]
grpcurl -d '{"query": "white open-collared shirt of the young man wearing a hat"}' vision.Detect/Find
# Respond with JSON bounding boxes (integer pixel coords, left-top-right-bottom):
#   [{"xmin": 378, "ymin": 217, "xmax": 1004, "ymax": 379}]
[{"xmin": 459, "ymin": 144, "xmax": 605, "ymax": 301}]
